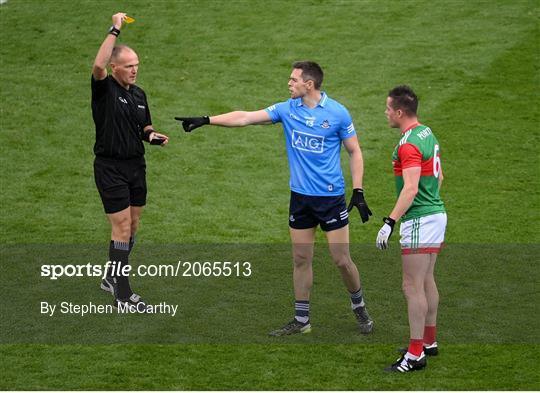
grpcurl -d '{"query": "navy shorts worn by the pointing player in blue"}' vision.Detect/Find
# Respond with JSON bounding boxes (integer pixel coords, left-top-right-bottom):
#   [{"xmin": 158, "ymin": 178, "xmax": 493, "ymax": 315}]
[{"xmin": 289, "ymin": 191, "xmax": 349, "ymax": 232}]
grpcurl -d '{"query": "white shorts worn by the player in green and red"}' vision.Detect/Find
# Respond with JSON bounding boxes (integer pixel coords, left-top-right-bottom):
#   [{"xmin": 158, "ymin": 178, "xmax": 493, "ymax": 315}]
[{"xmin": 399, "ymin": 213, "xmax": 446, "ymax": 254}]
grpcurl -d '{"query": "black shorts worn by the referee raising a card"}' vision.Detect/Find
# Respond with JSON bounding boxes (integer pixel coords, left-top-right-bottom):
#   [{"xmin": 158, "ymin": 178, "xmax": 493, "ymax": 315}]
[{"xmin": 94, "ymin": 157, "xmax": 146, "ymax": 214}]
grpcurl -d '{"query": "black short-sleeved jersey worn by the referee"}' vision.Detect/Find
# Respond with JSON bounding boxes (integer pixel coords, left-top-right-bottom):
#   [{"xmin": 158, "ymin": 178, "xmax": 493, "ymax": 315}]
[{"xmin": 91, "ymin": 75, "xmax": 152, "ymax": 160}]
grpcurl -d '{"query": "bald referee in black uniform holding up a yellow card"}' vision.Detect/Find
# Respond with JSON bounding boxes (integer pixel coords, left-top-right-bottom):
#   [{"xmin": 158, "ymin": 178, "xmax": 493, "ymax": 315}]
[{"xmin": 91, "ymin": 13, "xmax": 169, "ymax": 312}]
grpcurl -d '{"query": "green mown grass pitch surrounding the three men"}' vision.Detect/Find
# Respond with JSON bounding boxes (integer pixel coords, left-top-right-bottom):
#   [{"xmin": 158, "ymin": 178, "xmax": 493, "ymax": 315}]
[{"xmin": 0, "ymin": 0, "xmax": 540, "ymax": 390}]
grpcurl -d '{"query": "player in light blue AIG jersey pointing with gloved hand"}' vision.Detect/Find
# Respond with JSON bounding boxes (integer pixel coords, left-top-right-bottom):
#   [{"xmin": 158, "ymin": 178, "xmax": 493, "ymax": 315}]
[{"xmin": 176, "ymin": 61, "xmax": 373, "ymax": 336}]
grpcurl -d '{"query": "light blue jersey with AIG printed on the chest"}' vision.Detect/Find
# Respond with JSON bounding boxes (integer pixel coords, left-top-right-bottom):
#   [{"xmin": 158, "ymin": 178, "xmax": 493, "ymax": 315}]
[{"xmin": 266, "ymin": 92, "xmax": 356, "ymax": 196}]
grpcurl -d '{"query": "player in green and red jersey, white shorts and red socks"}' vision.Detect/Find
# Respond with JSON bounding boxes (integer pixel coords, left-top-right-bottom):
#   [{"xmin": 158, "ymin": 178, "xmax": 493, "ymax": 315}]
[{"xmin": 377, "ymin": 86, "xmax": 446, "ymax": 372}]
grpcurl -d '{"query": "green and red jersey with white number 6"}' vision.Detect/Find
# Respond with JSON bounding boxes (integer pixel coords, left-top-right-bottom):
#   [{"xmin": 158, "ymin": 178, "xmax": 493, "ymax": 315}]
[{"xmin": 392, "ymin": 124, "xmax": 445, "ymax": 221}]
